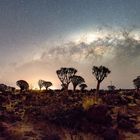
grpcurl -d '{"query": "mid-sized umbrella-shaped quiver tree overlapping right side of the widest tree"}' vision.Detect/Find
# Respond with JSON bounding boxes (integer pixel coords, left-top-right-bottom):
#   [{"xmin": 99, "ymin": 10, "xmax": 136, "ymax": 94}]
[{"xmin": 71, "ymin": 75, "xmax": 85, "ymax": 91}]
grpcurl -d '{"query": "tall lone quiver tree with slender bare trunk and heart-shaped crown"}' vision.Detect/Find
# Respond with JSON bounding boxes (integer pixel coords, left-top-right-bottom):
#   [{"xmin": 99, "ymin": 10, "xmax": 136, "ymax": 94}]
[{"xmin": 92, "ymin": 66, "xmax": 111, "ymax": 99}]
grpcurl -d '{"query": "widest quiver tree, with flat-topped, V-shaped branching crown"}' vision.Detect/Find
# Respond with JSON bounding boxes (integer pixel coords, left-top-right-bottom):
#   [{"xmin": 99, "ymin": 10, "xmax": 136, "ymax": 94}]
[{"xmin": 56, "ymin": 68, "xmax": 77, "ymax": 90}]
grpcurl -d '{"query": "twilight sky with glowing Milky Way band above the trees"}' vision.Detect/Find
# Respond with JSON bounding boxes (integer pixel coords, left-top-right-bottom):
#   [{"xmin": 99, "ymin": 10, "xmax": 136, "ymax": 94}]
[{"xmin": 0, "ymin": 0, "xmax": 140, "ymax": 88}]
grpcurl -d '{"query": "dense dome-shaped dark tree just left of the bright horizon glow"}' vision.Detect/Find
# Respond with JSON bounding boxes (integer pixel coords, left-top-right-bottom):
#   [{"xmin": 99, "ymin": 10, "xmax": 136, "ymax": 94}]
[{"xmin": 16, "ymin": 80, "xmax": 29, "ymax": 92}]
